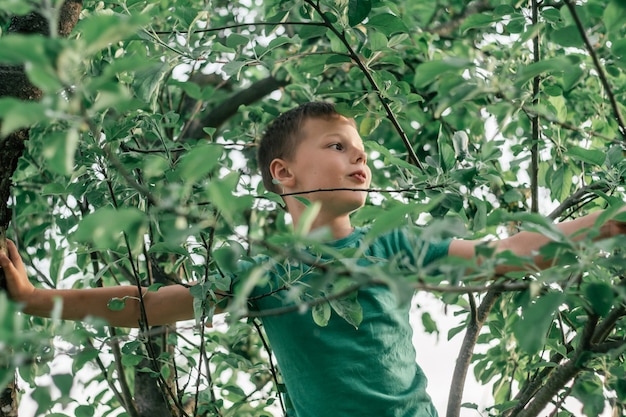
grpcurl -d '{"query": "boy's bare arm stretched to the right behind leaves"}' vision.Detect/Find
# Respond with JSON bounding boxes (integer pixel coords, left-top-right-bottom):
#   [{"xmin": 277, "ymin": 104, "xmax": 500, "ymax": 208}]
[{"xmin": 448, "ymin": 208, "xmax": 626, "ymax": 274}]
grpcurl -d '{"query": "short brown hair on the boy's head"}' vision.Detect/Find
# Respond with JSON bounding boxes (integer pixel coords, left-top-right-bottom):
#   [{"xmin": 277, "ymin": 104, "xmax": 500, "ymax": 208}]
[{"xmin": 257, "ymin": 101, "xmax": 339, "ymax": 194}]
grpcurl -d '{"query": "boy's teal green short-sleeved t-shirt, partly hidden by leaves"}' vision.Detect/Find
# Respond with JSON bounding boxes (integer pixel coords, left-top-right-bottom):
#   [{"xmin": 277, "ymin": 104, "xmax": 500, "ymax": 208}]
[{"xmin": 245, "ymin": 228, "xmax": 450, "ymax": 417}]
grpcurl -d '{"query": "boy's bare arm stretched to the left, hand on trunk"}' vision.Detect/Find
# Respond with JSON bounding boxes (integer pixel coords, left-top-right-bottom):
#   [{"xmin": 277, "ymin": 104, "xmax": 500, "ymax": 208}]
[{"xmin": 0, "ymin": 240, "xmax": 212, "ymax": 327}]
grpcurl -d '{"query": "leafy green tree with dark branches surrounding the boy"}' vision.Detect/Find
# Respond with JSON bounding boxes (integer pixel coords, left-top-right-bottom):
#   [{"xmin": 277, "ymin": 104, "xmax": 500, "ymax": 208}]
[{"xmin": 0, "ymin": 0, "xmax": 626, "ymax": 416}]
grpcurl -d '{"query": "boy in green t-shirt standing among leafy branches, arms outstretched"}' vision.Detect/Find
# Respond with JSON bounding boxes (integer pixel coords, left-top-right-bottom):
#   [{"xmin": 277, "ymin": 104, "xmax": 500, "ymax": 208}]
[{"xmin": 0, "ymin": 103, "xmax": 626, "ymax": 417}]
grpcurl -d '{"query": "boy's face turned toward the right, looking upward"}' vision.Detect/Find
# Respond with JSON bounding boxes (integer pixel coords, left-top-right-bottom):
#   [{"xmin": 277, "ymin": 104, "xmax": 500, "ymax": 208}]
[{"xmin": 280, "ymin": 116, "xmax": 372, "ymax": 215}]
